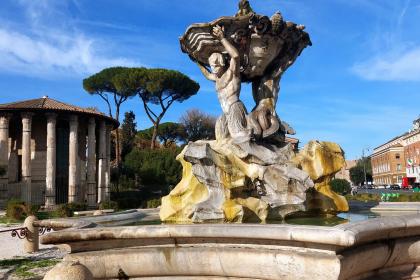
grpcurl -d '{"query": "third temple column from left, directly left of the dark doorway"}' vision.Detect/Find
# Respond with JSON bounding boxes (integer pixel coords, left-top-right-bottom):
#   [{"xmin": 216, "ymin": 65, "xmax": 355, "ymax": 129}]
[{"xmin": 45, "ymin": 113, "xmax": 57, "ymax": 207}]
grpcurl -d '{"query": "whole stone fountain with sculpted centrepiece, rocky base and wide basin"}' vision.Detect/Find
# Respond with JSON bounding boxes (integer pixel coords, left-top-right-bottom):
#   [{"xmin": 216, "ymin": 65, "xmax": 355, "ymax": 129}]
[{"xmin": 38, "ymin": 0, "xmax": 420, "ymax": 280}]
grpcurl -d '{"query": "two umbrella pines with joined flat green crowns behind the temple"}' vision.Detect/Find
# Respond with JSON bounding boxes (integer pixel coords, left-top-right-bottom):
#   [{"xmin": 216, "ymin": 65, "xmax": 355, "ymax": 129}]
[{"xmin": 83, "ymin": 67, "xmax": 200, "ymax": 150}]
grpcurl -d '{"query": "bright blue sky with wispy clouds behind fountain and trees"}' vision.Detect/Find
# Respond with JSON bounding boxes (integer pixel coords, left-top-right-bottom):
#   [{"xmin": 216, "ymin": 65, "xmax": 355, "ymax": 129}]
[{"xmin": 0, "ymin": 0, "xmax": 420, "ymax": 159}]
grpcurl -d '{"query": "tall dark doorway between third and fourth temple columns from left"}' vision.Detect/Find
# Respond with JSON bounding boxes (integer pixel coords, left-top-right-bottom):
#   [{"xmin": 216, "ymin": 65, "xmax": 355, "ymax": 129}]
[{"xmin": 55, "ymin": 121, "xmax": 70, "ymax": 204}]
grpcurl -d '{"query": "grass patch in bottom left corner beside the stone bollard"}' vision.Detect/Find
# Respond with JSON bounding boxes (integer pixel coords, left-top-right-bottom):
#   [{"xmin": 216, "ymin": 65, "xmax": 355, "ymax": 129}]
[{"xmin": 0, "ymin": 258, "xmax": 61, "ymax": 279}]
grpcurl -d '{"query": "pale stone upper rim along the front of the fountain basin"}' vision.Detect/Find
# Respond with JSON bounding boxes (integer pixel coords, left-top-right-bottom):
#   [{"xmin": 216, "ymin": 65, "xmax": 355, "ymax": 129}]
[{"xmin": 41, "ymin": 215, "xmax": 420, "ymax": 247}]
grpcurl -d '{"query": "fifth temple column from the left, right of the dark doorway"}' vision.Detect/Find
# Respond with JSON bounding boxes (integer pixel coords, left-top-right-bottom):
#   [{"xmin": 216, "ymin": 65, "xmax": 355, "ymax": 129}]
[{"xmin": 87, "ymin": 118, "xmax": 96, "ymax": 208}]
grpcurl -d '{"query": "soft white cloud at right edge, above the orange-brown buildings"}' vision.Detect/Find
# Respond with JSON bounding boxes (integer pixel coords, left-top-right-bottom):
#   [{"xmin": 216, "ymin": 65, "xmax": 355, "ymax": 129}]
[{"xmin": 351, "ymin": 46, "xmax": 420, "ymax": 81}]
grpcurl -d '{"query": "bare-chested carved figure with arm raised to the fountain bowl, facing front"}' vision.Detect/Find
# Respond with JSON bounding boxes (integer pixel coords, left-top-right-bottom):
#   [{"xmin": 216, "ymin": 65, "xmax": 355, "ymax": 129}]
[{"xmin": 198, "ymin": 26, "xmax": 251, "ymax": 143}]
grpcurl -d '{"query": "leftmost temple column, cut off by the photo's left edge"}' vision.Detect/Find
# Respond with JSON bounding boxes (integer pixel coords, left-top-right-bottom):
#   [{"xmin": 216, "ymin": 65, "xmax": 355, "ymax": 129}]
[{"xmin": 0, "ymin": 114, "xmax": 11, "ymax": 202}]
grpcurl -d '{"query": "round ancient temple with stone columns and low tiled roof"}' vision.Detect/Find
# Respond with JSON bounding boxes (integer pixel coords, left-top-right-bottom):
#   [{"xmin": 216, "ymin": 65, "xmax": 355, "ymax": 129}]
[{"xmin": 0, "ymin": 97, "xmax": 118, "ymax": 207}]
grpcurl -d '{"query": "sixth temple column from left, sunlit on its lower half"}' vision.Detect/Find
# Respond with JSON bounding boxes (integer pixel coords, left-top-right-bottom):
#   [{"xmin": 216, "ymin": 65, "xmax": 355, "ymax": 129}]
[{"xmin": 98, "ymin": 121, "xmax": 107, "ymax": 203}]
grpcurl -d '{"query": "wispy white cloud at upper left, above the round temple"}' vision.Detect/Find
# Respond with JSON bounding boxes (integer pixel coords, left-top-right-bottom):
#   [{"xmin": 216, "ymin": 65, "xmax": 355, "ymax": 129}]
[{"xmin": 0, "ymin": 29, "xmax": 134, "ymax": 78}]
